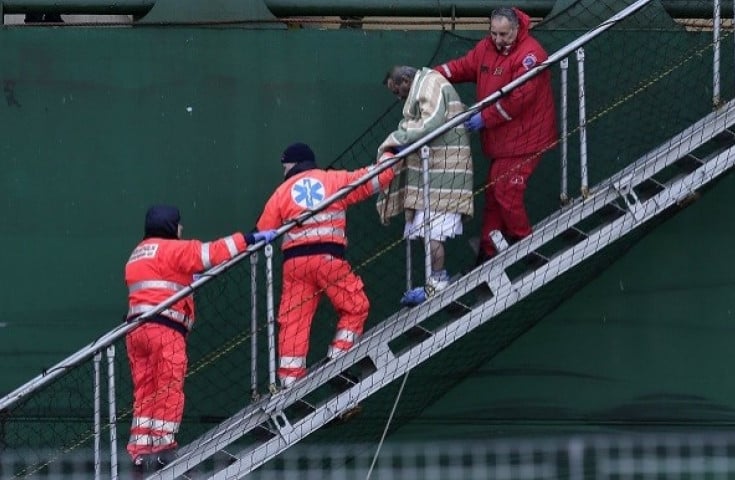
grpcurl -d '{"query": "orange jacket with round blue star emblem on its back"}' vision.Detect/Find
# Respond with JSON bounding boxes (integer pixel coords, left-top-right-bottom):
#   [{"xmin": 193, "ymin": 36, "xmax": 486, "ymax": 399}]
[{"xmin": 257, "ymin": 167, "xmax": 395, "ymax": 250}]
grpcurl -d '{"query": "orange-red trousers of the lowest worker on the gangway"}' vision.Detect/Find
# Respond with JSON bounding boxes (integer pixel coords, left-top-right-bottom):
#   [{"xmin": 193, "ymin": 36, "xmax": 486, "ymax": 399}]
[{"xmin": 125, "ymin": 323, "xmax": 187, "ymax": 460}]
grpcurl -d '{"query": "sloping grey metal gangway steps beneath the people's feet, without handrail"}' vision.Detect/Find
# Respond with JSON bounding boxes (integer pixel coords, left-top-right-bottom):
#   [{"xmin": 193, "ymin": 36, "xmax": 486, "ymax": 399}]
[{"xmin": 148, "ymin": 89, "xmax": 735, "ymax": 480}]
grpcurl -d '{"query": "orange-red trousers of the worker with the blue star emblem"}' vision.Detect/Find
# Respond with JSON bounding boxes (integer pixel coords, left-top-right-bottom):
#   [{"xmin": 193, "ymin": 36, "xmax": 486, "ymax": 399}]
[{"xmin": 278, "ymin": 255, "xmax": 370, "ymax": 387}]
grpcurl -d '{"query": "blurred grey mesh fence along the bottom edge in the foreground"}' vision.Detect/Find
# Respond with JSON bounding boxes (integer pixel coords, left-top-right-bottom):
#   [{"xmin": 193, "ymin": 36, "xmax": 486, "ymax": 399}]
[{"xmin": 8, "ymin": 432, "xmax": 735, "ymax": 480}]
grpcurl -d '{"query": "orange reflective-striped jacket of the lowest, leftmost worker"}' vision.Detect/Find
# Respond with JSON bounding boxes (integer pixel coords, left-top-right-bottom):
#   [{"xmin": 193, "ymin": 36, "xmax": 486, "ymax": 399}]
[{"xmin": 125, "ymin": 233, "xmax": 247, "ymax": 330}]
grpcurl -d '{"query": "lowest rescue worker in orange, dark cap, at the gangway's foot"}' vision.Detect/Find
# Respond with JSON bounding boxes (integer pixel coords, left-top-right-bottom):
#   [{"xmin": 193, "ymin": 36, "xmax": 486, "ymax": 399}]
[{"xmin": 125, "ymin": 205, "xmax": 275, "ymax": 478}]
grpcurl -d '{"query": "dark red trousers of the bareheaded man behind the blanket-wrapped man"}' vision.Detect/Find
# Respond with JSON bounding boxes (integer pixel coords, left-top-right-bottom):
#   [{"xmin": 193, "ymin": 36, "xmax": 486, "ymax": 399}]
[{"xmin": 480, "ymin": 155, "xmax": 541, "ymax": 257}]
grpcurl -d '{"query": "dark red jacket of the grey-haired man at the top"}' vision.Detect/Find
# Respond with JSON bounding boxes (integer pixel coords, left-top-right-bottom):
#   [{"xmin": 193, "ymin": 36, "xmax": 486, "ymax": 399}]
[{"xmin": 435, "ymin": 9, "xmax": 557, "ymax": 158}]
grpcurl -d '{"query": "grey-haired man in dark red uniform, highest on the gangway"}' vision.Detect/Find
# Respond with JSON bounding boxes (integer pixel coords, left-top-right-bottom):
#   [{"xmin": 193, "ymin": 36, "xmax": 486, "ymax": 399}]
[{"xmin": 436, "ymin": 7, "xmax": 557, "ymax": 261}]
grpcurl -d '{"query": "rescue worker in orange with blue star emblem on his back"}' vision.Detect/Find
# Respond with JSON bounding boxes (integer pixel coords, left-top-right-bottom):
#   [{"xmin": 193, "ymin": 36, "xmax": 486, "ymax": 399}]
[{"xmin": 257, "ymin": 143, "xmax": 396, "ymax": 388}]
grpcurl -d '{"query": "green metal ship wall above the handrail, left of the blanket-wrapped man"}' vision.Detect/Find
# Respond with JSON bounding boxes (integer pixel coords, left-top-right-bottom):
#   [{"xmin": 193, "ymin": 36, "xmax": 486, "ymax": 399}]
[{"xmin": 0, "ymin": 27, "xmax": 437, "ymax": 391}]
